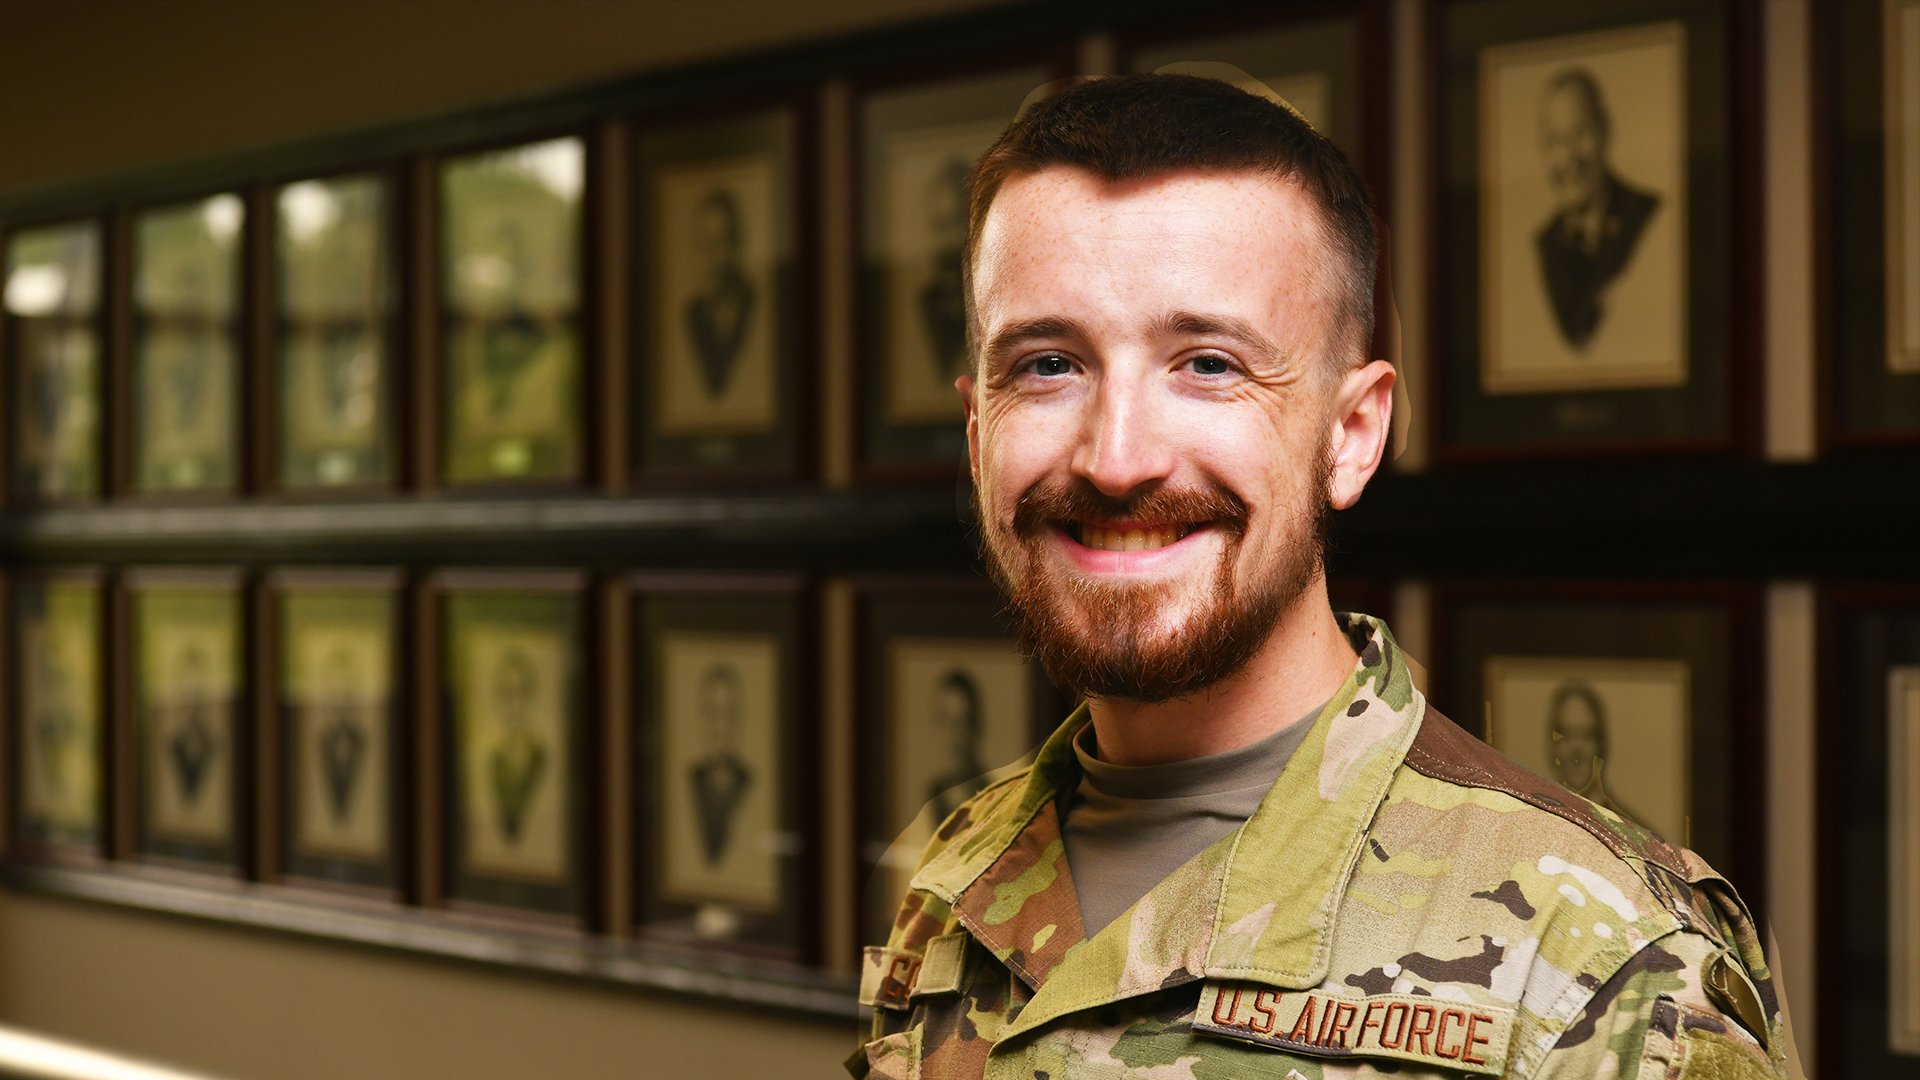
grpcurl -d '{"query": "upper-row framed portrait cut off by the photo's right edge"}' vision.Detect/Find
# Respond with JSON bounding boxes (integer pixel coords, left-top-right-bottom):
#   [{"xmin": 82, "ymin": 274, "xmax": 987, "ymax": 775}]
[{"xmin": 1814, "ymin": 0, "xmax": 1920, "ymax": 446}]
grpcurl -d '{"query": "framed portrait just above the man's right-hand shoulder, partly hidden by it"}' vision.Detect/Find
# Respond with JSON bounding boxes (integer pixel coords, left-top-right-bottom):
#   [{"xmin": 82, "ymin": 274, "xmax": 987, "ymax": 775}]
[{"xmin": 1428, "ymin": 584, "xmax": 1766, "ymax": 887}]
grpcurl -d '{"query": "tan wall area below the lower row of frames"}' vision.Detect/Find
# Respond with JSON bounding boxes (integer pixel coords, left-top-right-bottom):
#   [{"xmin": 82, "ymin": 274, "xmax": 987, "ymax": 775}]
[{"xmin": 0, "ymin": 892, "xmax": 854, "ymax": 1080}]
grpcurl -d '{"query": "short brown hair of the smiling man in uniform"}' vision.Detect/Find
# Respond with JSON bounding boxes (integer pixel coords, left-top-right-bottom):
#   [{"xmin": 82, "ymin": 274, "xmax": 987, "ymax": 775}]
[{"xmin": 964, "ymin": 75, "xmax": 1379, "ymax": 363}]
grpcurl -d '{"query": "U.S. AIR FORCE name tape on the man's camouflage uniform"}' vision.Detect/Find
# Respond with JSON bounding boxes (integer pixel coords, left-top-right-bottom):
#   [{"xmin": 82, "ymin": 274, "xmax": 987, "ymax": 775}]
[{"xmin": 1194, "ymin": 982, "xmax": 1513, "ymax": 1076}]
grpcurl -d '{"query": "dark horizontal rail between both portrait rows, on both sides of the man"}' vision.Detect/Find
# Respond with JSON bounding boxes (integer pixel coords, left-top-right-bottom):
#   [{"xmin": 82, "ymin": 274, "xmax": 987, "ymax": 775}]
[{"xmin": 0, "ymin": 455, "xmax": 1920, "ymax": 578}]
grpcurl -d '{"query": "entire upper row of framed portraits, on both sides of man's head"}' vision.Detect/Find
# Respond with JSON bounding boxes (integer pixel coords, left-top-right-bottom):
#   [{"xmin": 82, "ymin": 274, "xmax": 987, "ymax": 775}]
[{"xmin": 0, "ymin": 0, "xmax": 1920, "ymax": 503}]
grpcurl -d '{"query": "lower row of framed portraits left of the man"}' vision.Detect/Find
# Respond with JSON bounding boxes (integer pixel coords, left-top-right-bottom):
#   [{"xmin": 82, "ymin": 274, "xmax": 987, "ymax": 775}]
[{"xmin": 6, "ymin": 569, "xmax": 1066, "ymax": 963}]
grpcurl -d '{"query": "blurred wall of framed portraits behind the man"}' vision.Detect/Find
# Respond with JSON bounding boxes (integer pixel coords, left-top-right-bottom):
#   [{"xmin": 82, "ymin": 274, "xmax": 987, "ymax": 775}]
[{"xmin": 0, "ymin": 0, "xmax": 1920, "ymax": 1080}]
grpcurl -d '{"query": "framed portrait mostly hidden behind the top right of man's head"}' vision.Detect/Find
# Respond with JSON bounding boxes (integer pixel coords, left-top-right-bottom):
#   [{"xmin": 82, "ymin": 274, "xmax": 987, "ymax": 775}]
[{"xmin": 1121, "ymin": 4, "xmax": 1379, "ymax": 168}]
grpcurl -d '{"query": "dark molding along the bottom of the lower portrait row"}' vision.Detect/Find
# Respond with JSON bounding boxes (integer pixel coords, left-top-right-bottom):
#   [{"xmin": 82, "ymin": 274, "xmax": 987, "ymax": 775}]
[{"xmin": 0, "ymin": 865, "xmax": 860, "ymax": 1032}]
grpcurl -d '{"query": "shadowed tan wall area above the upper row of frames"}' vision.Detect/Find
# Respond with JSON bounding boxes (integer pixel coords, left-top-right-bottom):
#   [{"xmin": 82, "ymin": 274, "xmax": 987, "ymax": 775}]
[{"xmin": 0, "ymin": 0, "xmax": 998, "ymax": 192}]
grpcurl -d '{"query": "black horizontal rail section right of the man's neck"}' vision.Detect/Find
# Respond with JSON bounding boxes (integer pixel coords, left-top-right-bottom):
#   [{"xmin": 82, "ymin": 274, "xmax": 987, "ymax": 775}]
[{"xmin": 1329, "ymin": 455, "xmax": 1920, "ymax": 578}]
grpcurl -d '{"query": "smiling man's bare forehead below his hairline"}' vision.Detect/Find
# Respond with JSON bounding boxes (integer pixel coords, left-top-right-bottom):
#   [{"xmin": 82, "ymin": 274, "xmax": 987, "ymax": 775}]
[{"xmin": 973, "ymin": 165, "xmax": 1327, "ymax": 336}]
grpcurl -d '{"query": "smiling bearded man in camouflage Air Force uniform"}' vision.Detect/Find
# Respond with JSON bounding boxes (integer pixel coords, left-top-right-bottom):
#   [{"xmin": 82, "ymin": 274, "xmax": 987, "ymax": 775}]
[{"xmin": 849, "ymin": 75, "xmax": 1782, "ymax": 1080}]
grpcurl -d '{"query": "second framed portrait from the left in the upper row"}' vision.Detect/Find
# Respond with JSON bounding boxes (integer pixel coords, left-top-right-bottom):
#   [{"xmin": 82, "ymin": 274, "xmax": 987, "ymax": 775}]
[{"xmin": 131, "ymin": 192, "xmax": 246, "ymax": 494}]
